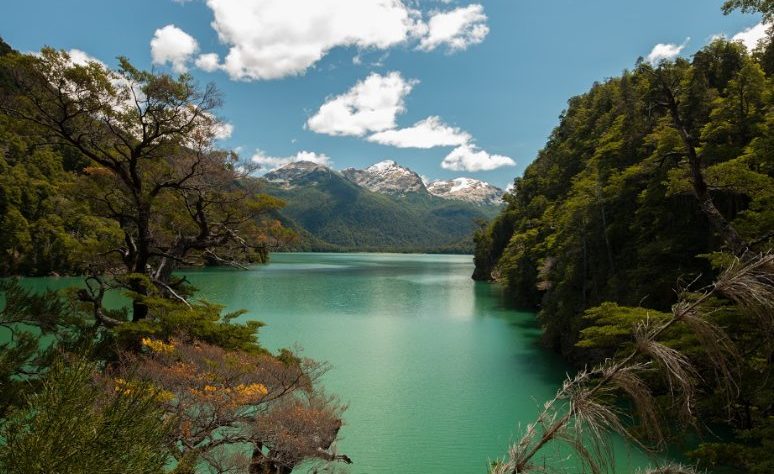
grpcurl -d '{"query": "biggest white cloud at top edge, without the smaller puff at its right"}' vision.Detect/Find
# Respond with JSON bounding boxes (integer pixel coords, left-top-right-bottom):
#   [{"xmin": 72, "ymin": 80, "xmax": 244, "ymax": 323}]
[{"xmin": 207, "ymin": 0, "xmax": 421, "ymax": 80}]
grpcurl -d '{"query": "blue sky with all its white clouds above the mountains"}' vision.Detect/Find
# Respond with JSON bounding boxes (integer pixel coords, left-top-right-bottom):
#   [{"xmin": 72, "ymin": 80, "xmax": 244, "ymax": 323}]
[{"xmin": 0, "ymin": 0, "xmax": 764, "ymax": 187}]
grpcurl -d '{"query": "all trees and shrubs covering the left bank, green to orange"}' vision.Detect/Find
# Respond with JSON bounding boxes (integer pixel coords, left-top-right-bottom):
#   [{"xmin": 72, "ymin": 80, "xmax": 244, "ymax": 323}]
[{"xmin": 0, "ymin": 39, "xmax": 350, "ymax": 473}]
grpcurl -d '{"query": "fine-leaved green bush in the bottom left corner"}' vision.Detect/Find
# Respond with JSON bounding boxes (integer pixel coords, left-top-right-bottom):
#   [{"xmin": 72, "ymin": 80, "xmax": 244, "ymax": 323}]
[{"xmin": 0, "ymin": 356, "xmax": 170, "ymax": 474}]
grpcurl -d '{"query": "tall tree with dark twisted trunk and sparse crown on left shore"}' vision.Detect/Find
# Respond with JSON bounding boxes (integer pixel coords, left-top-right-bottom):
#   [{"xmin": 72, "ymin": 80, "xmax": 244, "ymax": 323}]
[{"xmin": 2, "ymin": 49, "xmax": 280, "ymax": 320}]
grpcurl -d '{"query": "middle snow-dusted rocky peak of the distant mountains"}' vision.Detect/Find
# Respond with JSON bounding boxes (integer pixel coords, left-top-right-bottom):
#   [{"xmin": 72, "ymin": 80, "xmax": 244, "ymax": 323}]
[{"xmin": 341, "ymin": 160, "xmax": 427, "ymax": 195}]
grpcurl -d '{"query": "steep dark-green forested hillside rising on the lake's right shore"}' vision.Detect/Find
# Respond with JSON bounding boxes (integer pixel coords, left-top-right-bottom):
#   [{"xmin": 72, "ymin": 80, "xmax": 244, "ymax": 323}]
[{"xmin": 474, "ymin": 17, "xmax": 774, "ymax": 472}]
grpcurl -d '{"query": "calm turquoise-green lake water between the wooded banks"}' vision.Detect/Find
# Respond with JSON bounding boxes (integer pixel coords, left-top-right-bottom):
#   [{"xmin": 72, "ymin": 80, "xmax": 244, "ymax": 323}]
[{"xmin": 19, "ymin": 254, "xmax": 660, "ymax": 473}]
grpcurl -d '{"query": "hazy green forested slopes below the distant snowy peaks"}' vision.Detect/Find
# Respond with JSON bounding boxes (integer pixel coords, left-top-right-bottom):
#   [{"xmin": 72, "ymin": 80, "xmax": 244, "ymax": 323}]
[{"xmin": 263, "ymin": 165, "xmax": 498, "ymax": 253}]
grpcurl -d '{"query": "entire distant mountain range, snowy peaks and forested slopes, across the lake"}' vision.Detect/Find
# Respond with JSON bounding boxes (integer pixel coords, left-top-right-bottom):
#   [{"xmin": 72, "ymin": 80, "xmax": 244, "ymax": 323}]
[{"xmin": 261, "ymin": 161, "xmax": 503, "ymax": 252}]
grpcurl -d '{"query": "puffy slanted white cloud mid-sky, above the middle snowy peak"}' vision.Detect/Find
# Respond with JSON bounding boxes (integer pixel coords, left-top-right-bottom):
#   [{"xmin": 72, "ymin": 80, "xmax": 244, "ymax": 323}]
[{"xmin": 306, "ymin": 72, "xmax": 416, "ymax": 136}]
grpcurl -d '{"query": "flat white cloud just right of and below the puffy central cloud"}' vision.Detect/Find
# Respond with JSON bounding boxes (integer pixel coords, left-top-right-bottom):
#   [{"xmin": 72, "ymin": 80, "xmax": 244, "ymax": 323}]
[{"xmin": 368, "ymin": 115, "xmax": 472, "ymax": 148}]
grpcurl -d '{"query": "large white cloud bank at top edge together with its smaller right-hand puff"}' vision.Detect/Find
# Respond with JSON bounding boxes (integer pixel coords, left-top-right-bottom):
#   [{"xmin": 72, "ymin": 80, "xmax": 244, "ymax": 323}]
[{"xmin": 197, "ymin": 0, "xmax": 489, "ymax": 80}]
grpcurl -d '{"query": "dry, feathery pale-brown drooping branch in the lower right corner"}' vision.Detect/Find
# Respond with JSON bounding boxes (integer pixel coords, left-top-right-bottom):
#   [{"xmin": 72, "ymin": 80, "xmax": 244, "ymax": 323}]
[{"xmin": 491, "ymin": 253, "xmax": 774, "ymax": 474}]
